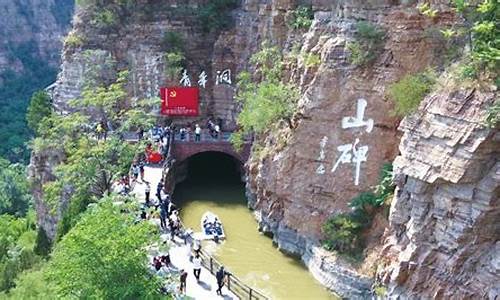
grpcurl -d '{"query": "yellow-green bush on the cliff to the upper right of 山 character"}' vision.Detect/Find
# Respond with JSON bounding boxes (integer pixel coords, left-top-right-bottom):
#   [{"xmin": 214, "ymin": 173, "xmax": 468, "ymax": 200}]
[{"xmin": 388, "ymin": 71, "xmax": 436, "ymax": 116}]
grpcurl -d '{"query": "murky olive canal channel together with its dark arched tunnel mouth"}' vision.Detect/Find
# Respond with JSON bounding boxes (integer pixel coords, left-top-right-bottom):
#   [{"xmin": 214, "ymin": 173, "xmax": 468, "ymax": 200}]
[{"xmin": 174, "ymin": 152, "xmax": 334, "ymax": 299}]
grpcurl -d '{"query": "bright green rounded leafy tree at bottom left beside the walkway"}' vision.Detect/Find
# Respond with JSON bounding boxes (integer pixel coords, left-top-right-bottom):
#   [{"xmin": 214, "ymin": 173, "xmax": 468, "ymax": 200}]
[{"xmin": 47, "ymin": 198, "xmax": 159, "ymax": 299}]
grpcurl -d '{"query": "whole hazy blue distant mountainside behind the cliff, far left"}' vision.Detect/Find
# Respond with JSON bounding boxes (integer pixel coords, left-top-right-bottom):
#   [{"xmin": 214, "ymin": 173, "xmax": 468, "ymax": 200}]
[{"xmin": 0, "ymin": 0, "xmax": 74, "ymax": 162}]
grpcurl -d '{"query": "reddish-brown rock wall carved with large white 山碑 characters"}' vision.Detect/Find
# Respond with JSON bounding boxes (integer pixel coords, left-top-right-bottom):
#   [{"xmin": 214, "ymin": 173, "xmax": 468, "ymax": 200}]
[{"xmin": 244, "ymin": 1, "xmax": 454, "ymax": 298}]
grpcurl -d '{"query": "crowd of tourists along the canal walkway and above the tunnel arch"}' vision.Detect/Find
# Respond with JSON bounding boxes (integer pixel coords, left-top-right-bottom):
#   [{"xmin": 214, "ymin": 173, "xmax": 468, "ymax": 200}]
[{"xmin": 110, "ymin": 120, "xmax": 233, "ymax": 296}]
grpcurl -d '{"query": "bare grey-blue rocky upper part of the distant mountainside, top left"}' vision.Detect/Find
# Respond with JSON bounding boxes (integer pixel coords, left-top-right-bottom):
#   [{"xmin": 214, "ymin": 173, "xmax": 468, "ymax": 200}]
[{"xmin": 0, "ymin": 0, "xmax": 74, "ymax": 73}]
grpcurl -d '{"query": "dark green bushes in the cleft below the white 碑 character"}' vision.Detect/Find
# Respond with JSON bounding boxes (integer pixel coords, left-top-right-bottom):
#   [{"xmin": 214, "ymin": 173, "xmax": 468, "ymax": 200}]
[{"xmin": 323, "ymin": 164, "xmax": 394, "ymax": 259}]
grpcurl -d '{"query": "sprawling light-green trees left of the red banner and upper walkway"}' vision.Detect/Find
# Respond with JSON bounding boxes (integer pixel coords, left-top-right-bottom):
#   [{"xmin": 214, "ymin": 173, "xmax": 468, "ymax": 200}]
[{"xmin": 33, "ymin": 72, "xmax": 153, "ymax": 240}]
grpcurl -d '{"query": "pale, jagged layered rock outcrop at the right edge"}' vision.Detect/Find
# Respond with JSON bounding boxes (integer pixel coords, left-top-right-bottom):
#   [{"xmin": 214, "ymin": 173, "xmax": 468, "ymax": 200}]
[{"xmin": 379, "ymin": 89, "xmax": 500, "ymax": 299}]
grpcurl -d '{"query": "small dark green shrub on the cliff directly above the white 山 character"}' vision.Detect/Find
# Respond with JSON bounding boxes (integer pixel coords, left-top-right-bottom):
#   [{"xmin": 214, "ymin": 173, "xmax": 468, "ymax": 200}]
[{"xmin": 347, "ymin": 21, "xmax": 385, "ymax": 66}]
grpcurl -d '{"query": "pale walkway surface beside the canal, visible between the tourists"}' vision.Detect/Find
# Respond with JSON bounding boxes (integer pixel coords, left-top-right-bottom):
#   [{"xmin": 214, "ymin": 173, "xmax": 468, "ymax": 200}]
[{"xmin": 132, "ymin": 166, "xmax": 238, "ymax": 300}]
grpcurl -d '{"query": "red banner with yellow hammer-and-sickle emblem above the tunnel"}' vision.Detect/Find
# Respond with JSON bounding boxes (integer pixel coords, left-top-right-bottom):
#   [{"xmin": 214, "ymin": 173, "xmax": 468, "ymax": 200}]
[{"xmin": 160, "ymin": 87, "xmax": 200, "ymax": 117}]
